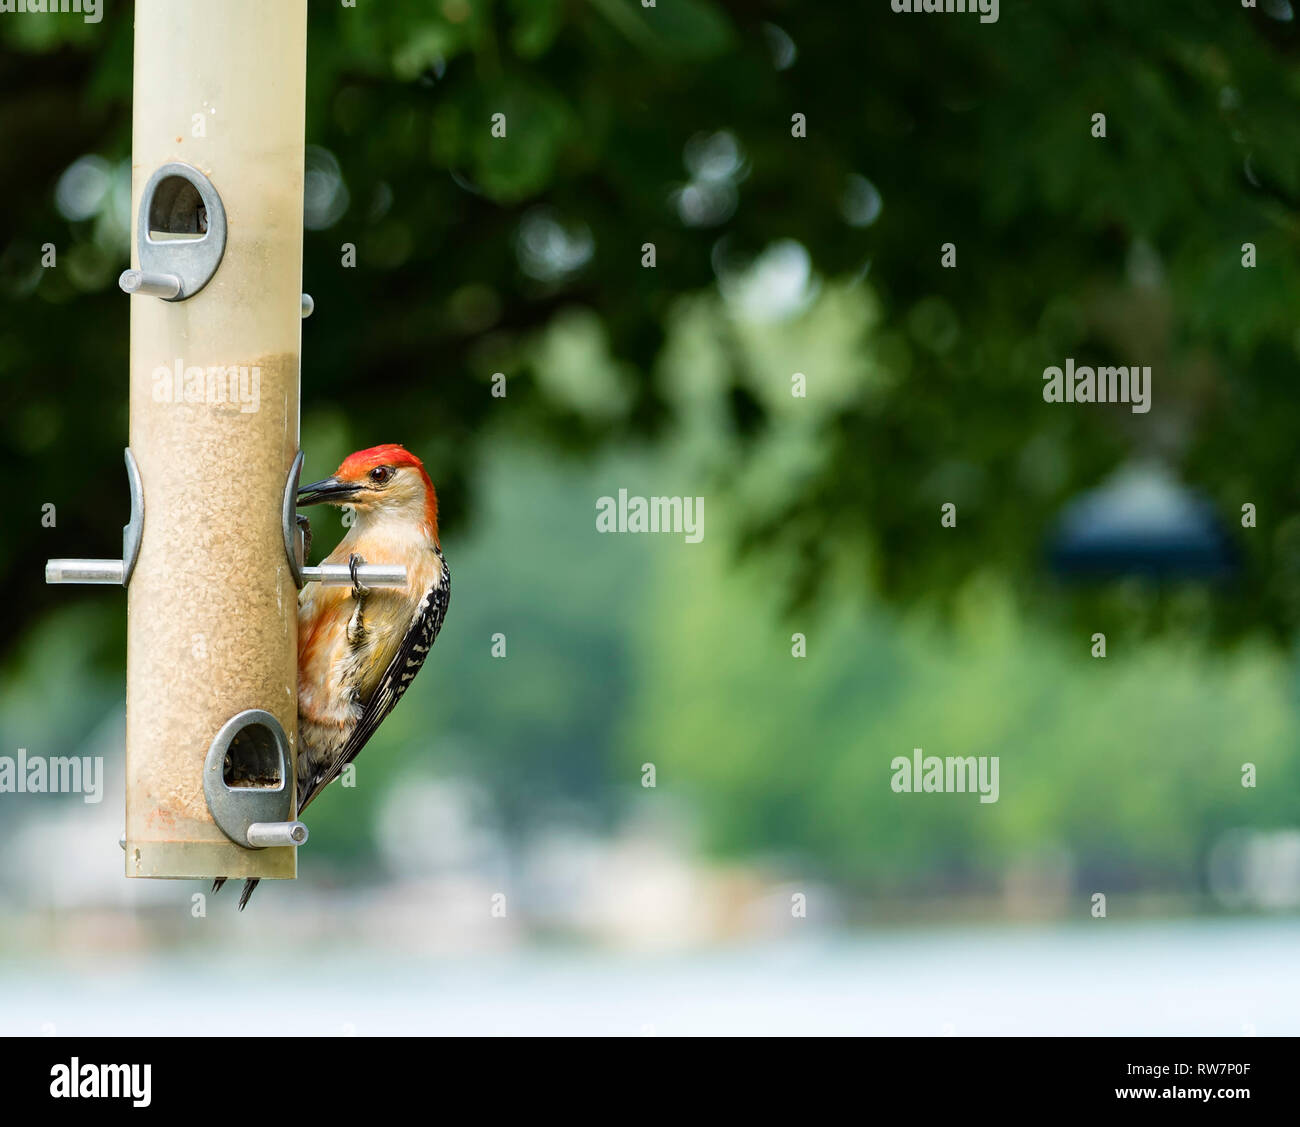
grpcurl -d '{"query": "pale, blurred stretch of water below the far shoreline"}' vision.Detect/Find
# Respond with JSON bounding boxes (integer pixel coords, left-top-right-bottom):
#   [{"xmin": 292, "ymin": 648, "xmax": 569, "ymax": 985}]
[{"xmin": 0, "ymin": 909, "xmax": 1300, "ymax": 1037}]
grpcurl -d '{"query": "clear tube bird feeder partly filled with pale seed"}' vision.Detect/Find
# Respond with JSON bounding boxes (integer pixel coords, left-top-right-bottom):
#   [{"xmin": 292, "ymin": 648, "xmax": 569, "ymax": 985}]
[{"xmin": 47, "ymin": 0, "xmax": 404, "ymax": 877}]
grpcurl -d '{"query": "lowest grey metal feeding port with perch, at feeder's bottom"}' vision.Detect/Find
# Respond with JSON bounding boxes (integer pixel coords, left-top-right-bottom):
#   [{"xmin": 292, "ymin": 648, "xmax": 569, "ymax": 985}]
[{"xmin": 203, "ymin": 708, "xmax": 307, "ymax": 849}]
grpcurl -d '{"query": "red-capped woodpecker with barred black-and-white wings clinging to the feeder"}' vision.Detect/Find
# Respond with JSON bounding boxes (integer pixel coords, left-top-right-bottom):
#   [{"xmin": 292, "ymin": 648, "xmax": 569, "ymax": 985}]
[{"xmin": 213, "ymin": 443, "xmax": 451, "ymax": 911}]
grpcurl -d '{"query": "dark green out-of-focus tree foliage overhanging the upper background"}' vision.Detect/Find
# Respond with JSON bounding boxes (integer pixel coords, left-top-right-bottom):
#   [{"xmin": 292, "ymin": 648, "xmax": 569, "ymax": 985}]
[{"xmin": 0, "ymin": 0, "xmax": 1300, "ymax": 649}]
